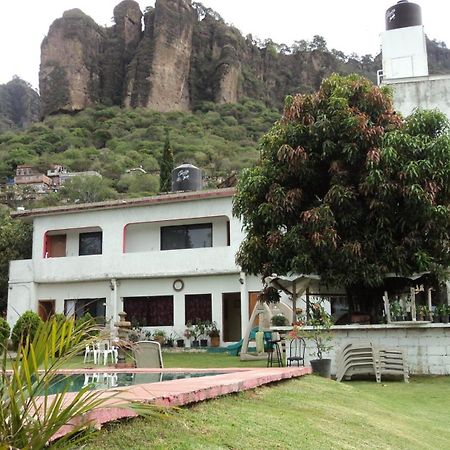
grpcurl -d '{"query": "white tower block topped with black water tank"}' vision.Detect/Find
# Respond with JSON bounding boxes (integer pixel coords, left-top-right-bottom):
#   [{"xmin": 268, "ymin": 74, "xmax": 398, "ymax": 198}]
[{"xmin": 381, "ymin": 0, "xmax": 428, "ymax": 80}]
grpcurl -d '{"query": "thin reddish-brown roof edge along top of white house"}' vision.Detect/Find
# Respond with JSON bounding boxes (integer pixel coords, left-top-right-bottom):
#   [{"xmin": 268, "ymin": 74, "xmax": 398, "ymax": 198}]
[{"xmin": 11, "ymin": 188, "xmax": 235, "ymax": 219}]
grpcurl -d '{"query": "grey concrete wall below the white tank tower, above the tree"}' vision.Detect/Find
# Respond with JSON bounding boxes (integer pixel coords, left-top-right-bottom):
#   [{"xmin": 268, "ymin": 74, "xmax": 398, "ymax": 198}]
[{"xmin": 382, "ymin": 75, "xmax": 450, "ymax": 118}]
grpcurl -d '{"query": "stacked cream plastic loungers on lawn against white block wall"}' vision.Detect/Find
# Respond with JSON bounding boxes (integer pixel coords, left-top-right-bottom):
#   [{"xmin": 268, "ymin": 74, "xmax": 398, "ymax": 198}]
[{"xmin": 336, "ymin": 343, "xmax": 409, "ymax": 383}]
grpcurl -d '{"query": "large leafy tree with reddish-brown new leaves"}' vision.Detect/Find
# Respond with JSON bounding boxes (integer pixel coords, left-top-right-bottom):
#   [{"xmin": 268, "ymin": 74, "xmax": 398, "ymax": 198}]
[{"xmin": 234, "ymin": 75, "xmax": 450, "ymax": 291}]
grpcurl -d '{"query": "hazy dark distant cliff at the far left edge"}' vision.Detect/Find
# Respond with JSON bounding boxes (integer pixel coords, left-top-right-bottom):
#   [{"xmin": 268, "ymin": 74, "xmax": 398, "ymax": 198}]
[{"xmin": 0, "ymin": 78, "xmax": 40, "ymax": 132}]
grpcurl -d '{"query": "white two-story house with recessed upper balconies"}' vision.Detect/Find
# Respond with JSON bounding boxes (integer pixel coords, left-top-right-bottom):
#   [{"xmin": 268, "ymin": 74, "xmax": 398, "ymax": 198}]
[{"xmin": 8, "ymin": 188, "xmax": 261, "ymax": 343}]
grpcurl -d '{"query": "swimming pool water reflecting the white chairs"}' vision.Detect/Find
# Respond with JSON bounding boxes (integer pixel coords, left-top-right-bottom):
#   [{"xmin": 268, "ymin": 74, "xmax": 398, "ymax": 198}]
[{"xmin": 48, "ymin": 372, "xmax": 222, "ymax": 395}]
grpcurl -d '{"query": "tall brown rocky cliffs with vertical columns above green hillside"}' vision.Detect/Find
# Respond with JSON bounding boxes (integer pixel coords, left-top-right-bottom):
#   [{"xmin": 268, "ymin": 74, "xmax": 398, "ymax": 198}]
[{"xmin": 40, "ymin": 0, "xmax": 450, "ymax": 115}]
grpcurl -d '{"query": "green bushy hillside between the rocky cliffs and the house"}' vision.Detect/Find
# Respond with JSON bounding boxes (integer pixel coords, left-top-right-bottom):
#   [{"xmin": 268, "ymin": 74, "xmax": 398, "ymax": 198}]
[{"xmin": 0, "ymin": 100, "xmax": 280, "ymax": 203}]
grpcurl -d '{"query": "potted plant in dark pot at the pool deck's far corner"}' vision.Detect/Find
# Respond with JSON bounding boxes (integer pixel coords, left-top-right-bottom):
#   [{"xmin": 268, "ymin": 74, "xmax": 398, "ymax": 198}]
[{"xmin": 289, "ymin": 303, "xmax": 333, "ymax": 378}]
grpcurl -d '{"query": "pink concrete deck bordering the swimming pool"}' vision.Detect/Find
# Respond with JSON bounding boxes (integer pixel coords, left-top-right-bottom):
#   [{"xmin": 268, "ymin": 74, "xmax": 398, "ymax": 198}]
[{"xmin": 54, "ymin": 367, "xmax": 311, "ymax": 438}]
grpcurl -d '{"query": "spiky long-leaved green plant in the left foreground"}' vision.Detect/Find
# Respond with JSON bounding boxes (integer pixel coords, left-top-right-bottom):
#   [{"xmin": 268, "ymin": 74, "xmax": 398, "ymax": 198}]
[{"xmin": 0, "ymin": 319, "xmax": 114, "ymax": 450}]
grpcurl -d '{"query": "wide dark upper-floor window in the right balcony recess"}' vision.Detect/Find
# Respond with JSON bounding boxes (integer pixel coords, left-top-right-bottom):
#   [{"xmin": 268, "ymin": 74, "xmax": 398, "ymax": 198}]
[{"xmin": 161, "ymin": 223, "xmax": 212, "ymax": 250}]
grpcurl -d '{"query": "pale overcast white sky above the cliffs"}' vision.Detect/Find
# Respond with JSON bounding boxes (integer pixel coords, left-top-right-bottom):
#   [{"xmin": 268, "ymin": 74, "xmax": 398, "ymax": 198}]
[{"xmin": 0, "ymin": 0, "xmax": 450, "ymax": 87}]
